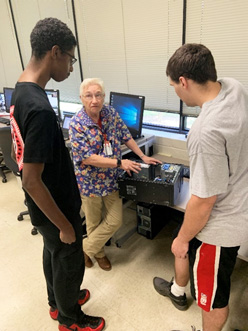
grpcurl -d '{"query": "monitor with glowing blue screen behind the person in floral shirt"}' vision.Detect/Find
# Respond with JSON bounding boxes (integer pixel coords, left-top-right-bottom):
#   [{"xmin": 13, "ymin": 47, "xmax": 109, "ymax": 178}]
[{"xmin": 109, "ymin": 92, "xmax": 145, "ymax": 139}]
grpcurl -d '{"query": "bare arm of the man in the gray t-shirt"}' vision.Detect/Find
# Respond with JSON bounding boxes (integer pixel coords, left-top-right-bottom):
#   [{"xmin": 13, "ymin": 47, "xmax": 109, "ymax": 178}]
[{"xmin": 171, "ymin": 195, "xmax": 217, "ymax": 258}]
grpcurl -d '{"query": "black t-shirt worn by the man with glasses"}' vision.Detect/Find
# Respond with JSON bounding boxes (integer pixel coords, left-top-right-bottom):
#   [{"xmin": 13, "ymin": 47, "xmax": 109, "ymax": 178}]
[{"xmin": 11, "ymin": 82, "xmax": 81, "ymax": 226}]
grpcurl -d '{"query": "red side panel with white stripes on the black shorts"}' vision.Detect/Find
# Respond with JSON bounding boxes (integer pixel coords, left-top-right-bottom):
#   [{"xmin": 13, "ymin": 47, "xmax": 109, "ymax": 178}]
[{"xmin": 193, "ymin": 243, "xmax": 220, "ymax": 311}]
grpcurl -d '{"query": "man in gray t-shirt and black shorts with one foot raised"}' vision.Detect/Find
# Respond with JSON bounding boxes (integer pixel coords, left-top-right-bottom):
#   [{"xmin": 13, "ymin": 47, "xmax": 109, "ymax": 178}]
[{"xmin": 154, "ymin": 44, "xmax": 248, "ymax": 331}]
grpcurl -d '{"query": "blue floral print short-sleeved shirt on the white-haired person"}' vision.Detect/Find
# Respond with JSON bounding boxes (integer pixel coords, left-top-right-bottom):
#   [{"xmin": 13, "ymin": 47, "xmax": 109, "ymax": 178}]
[{"xmin": 69, "ymin": 105, "xmax": 132, "ymax": 197}]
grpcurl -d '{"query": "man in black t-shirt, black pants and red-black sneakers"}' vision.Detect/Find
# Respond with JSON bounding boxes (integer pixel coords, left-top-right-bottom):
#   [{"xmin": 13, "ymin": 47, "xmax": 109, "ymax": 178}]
[{"xmin": 10, "ymin": 18, "xmax": 105, "ymax": 331}]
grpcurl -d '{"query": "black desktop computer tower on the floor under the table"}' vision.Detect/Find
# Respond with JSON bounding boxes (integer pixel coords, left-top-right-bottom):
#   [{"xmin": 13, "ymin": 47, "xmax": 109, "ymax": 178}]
[{"xmin": 136, "ymin": 202, "xmax": 170, "ymax": 239}]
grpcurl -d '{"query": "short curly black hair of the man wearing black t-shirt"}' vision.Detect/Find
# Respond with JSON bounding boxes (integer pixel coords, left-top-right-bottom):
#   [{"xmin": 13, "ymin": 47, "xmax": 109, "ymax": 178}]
[{"xmin": 30, "ymin": 17, "xmax": 77, "ymax": 59}]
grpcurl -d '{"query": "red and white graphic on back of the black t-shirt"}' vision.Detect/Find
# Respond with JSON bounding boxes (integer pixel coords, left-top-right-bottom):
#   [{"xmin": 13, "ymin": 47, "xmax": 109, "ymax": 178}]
[{"xmin": 10, "ymin": 106, "xmax": 24, "ymax": 171}]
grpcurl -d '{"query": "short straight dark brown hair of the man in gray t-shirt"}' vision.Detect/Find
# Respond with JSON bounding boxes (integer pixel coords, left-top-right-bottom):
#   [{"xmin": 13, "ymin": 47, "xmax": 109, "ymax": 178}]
[{"xmin": 166, "ymin": 44, "xmax": 217, "ymax": 84}]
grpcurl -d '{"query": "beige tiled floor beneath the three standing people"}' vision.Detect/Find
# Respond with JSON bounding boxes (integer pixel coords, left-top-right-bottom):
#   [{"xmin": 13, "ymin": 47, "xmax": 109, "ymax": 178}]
[{"xmin": 0, "ymin": 174, "xmax": 248, "ymax": 331}]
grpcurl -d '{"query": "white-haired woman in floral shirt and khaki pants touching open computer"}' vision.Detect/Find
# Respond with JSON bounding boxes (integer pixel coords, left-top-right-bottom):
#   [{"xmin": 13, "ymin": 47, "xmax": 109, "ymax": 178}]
[{"xmin": 69, "ymin": 78, "xmax": 159, "ymax": 270}]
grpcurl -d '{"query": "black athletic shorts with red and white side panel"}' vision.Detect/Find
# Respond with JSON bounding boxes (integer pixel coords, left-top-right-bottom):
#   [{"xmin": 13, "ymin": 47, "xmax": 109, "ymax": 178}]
[{"xmin": 189, "ymin": 238, "xmax": 240, "ymax": 312}]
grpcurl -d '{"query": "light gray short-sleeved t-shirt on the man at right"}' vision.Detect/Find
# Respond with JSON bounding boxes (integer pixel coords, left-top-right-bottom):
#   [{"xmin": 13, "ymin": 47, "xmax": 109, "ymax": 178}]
[{"xmin": 187, "ymin": 78, "xmax": 248, "ymax": 247}]
